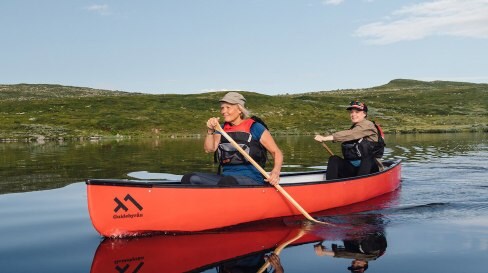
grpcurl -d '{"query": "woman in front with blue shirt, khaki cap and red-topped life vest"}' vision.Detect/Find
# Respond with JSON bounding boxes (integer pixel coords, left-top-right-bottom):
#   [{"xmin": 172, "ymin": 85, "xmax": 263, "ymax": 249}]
[{"xmin": 181, "ymin": 92, "xmax": 283, "ymax": 185}]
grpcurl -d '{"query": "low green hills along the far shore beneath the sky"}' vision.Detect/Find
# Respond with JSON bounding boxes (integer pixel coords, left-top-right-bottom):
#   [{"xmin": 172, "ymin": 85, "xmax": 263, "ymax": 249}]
[{"xmin": 0, "ymin": 79, "xmax": 488, "ymax": 142}]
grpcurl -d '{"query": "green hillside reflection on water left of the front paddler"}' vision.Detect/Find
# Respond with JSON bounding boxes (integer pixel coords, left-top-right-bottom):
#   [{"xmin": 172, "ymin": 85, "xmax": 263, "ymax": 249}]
[{"xmin": 0, "ymin": 139, "xmax": 208, "ymax": 194}]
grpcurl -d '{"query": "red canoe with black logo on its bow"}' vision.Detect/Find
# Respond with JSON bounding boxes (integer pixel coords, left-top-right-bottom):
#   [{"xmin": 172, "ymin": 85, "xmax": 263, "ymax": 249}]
[{"xmin": 86, "ymin": 160, "xmax": 401, "ymax": 236}]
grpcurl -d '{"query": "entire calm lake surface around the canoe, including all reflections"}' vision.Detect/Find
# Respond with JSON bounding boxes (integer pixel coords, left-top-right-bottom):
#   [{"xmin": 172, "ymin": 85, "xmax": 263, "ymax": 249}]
[{"xmin": 0, "ymin": 133, "xmax": 488, "ymax": 273}]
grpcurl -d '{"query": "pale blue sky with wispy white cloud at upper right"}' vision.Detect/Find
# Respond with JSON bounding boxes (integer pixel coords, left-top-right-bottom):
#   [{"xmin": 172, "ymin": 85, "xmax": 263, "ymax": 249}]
[{"xmin": 0, "ymin": 0, "xmax": 488, "ymax": 95}]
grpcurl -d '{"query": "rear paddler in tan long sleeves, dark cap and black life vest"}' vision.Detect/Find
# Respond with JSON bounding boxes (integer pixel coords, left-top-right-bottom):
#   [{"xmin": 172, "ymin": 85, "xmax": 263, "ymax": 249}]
[{"xmin": 315, "ymin": 101, "xmax": 384, "ymax": 180}]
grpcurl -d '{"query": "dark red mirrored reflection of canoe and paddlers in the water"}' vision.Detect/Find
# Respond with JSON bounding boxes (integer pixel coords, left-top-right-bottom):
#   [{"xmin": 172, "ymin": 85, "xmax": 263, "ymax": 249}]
[{"xmin": 90, "ymin": 191, "xmax": 398, "ymax": 273}]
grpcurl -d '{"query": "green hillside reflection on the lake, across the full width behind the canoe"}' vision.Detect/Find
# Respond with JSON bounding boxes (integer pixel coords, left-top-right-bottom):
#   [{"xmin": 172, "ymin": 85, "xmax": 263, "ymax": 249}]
[{"xmin": 0, "ymin": 133, "xmax": 488, "ymax": 194}]
